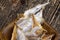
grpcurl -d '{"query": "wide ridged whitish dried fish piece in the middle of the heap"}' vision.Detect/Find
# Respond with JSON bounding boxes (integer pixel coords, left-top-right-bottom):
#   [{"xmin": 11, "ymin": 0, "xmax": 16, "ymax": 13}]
[{"xmin": 16, "ymin": 18, "xmax": 32, "ymax": 32}]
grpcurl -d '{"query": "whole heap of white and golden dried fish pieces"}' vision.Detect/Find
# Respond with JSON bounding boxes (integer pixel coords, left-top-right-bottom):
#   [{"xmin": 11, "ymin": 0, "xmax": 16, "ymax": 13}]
[{"xmin": 16, "ymin": 2, "xmax": 52, "ymax": 40}]
